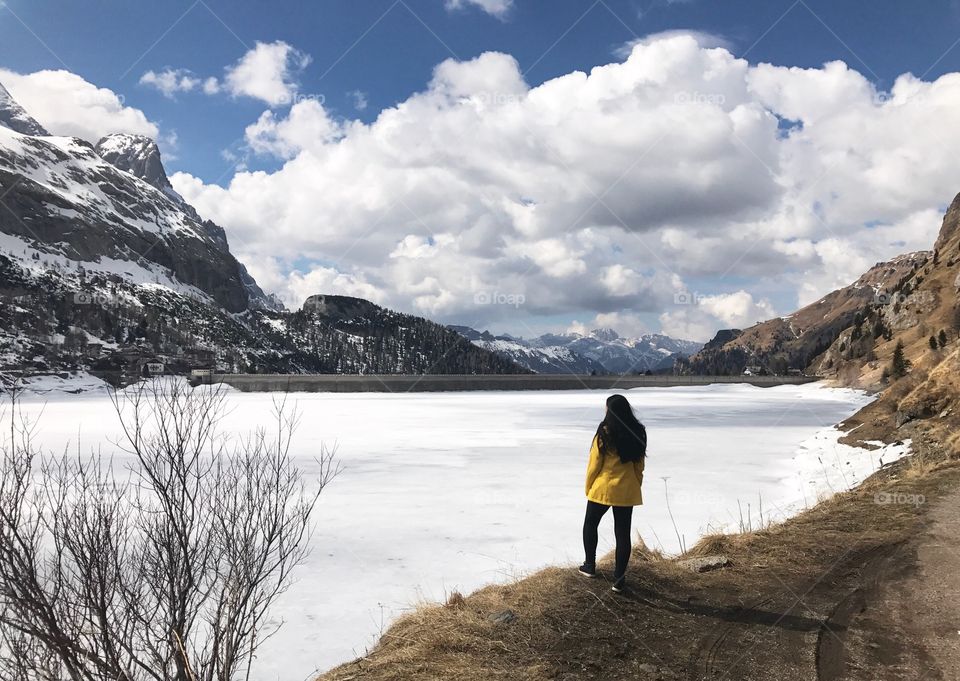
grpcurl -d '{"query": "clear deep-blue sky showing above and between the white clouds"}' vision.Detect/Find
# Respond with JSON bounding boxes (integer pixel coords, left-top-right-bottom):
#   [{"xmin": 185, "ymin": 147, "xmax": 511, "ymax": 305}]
[{"xmin": 0, "ymin": 0, "xmax": 960, "ymax": 181}]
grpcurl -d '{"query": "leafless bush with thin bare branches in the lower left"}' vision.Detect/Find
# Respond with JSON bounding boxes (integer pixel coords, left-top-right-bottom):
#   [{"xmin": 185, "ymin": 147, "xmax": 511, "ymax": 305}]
[{"xmin": 0, "ymin": 383, "xmax": 338, "ymax": 681}]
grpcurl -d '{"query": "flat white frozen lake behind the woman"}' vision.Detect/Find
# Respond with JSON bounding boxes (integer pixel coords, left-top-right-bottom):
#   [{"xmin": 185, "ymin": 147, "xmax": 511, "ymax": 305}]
[{"xmin": 13, "ymin": 384, "xmax": 900, "ymax": 681}]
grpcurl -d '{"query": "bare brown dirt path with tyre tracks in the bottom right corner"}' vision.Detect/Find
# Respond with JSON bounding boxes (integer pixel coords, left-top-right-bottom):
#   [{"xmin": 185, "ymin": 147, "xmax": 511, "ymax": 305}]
[{"xmin": 686, "ymin": 478, "xmax": 960, "ymax": 681}]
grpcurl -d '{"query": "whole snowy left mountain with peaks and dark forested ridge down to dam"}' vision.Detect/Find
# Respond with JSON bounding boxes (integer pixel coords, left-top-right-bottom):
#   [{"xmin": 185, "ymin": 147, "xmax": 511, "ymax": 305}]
[{"xmin": 0, "ymin": 82, "xmax": 524, "ymax": 382}]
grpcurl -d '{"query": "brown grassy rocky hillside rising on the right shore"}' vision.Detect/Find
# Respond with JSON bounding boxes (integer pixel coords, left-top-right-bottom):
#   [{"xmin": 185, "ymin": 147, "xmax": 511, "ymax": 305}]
[{"xmin": 681, "ymin": 195, "xmax": 960, "ymax": 382}]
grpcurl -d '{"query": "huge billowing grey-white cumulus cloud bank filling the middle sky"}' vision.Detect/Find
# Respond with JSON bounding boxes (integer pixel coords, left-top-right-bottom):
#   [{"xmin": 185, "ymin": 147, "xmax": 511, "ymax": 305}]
[{"xmin": 173, "ymin": 34, "xmax": 960, "ymax": 339}]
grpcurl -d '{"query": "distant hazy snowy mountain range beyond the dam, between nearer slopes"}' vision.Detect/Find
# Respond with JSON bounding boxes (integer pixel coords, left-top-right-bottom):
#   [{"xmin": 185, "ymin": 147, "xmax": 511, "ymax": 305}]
[{"xmin": 451, "ymin": 326, "xmax": 702, "ymax": 374}]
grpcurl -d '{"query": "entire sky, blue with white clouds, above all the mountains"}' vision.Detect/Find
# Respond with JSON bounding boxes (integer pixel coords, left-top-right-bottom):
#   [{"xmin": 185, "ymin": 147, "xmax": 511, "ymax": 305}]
[{"xmin": 0, "ymin": 0, "xmax": 960, "ymax": 338}]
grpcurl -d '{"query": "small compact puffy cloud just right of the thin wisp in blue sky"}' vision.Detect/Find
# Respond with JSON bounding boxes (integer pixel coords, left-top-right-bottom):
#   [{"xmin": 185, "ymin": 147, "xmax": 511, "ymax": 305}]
[{"xmin": 223, "ymin": 40, "xmax": 310, "ymax": 106}]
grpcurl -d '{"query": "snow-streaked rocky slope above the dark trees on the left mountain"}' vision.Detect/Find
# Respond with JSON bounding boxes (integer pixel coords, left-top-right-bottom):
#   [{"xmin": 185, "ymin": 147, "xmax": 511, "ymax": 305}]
[{"xmin": 0, "ymin": 122, "xmax": 262, "ymax": 312}]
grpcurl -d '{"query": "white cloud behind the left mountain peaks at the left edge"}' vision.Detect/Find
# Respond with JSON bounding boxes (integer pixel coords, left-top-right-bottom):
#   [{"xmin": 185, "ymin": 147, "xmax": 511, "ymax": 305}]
[{"xmin": 0, "ymin": 69, "xmax": 159, "ymax": 142}]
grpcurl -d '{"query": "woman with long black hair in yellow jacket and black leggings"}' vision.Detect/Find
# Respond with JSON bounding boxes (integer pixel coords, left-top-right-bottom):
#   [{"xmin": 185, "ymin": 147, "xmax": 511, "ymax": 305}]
[{"xmin": 580, "ymin": 395, "xmax": 647, "ymax": 593}]
